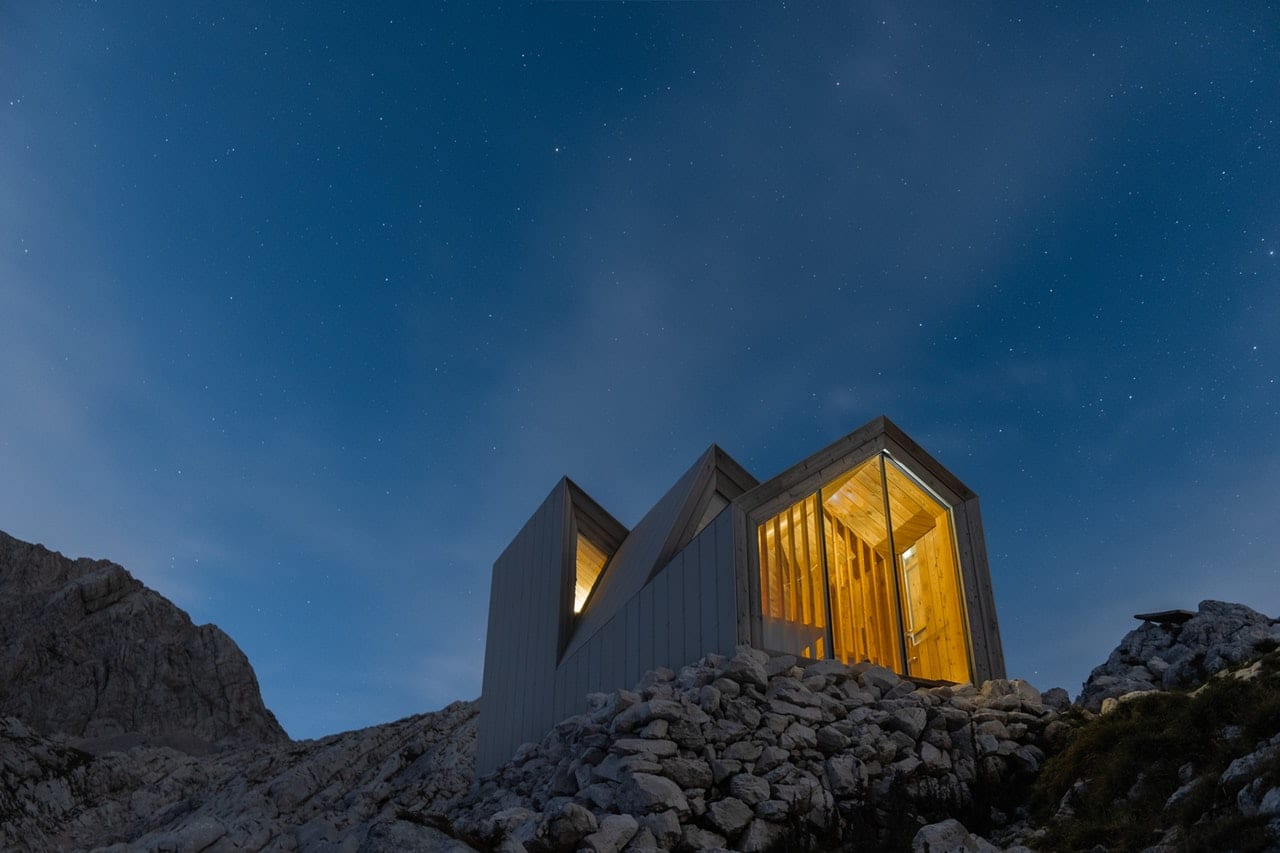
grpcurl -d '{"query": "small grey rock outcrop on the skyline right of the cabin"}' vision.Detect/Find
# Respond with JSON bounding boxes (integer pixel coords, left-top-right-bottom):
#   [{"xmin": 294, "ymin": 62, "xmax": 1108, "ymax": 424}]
[{"xmin": 1076, "ymin": 601, "xmax": 1280, "ymax": 711}]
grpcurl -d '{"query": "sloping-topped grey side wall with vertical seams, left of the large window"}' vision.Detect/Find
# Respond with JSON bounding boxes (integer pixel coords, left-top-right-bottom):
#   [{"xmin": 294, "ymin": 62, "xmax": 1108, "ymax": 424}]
[{"xmin": 547, "ymin": 508, "xmax": 737, "ymax": 729}]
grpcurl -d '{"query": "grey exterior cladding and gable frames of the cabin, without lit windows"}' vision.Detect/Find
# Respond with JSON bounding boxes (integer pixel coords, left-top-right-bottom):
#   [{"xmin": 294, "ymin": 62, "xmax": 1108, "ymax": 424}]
[{"xmin": 476, "ymin": 418, "xmax": 1005, "ymax": 774}]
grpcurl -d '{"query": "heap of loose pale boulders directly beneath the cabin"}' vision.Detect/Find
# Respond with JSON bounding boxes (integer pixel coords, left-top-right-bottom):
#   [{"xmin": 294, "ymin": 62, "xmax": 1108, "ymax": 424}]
[{"xmin": 448, "ymin": 646, "xmax": 1066, "ymax": 850}]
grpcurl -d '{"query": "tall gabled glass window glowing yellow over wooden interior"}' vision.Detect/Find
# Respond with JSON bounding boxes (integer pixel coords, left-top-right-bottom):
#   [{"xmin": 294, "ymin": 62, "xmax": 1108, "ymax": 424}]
[{"xmin": 756, "ymin": 455, "xmax": 969, "ymax": 681}]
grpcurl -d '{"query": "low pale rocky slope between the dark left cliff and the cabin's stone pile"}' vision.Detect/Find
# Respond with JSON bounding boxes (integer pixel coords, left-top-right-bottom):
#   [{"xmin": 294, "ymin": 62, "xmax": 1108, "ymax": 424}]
[{"xmin": 0, "ymin": 702, "xmax": 476, "ymax": 853}]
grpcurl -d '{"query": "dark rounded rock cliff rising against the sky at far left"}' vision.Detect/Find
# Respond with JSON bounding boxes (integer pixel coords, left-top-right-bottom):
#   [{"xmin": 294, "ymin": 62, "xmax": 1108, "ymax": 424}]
[{"xmin": 0, "ymin": 533, "xmax": 288, "ymax": 752}]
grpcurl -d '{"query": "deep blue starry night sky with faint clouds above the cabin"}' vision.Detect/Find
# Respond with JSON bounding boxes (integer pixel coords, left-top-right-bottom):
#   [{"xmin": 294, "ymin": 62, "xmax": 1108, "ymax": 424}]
[{"xmin": 0, "ymin": 1, "xmax": 1280, "ymax": 736}]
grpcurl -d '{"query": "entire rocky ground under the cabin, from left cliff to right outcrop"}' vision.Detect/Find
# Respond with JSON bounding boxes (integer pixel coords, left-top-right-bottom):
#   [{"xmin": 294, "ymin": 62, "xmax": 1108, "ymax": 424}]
[{"xmin": 0, "ymin": 534, "xmax": 1280, "ymax": 853}]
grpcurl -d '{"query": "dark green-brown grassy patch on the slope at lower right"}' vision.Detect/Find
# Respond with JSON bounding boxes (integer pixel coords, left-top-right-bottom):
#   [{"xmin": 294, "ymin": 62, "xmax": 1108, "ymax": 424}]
[{"xmin": 1032, "ymin": 651, "xmax": 1280, "ymax": 850}]
